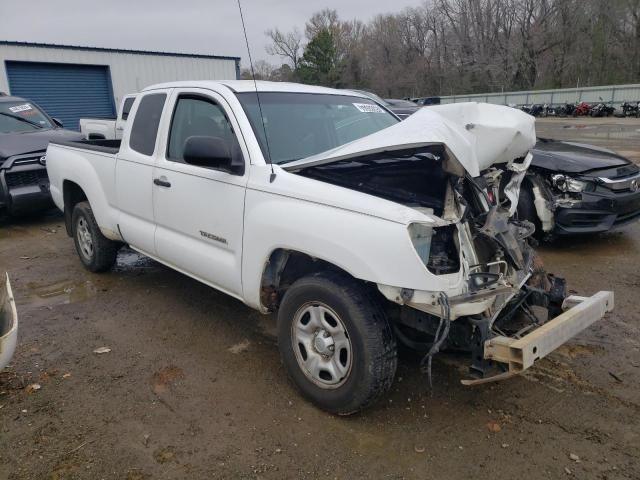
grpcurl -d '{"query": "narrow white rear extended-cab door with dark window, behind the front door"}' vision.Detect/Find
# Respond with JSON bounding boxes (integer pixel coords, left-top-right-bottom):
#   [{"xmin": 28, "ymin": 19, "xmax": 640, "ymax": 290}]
[{"xmin": 115, "ymin": 90, "xmax": 170, "ymax": 256}]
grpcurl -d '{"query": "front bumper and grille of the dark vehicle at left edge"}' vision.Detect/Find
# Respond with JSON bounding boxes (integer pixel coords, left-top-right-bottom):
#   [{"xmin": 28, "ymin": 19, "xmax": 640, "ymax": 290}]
[{"xmin": 0, "ymin": 152, "xmax": 53, "ymax": 215}]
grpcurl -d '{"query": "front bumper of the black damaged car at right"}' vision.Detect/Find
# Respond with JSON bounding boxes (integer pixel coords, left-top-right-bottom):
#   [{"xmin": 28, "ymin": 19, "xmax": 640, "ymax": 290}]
[{"xmin": 555, "ymin": 190, "xmax": 640, "ymax": 235}]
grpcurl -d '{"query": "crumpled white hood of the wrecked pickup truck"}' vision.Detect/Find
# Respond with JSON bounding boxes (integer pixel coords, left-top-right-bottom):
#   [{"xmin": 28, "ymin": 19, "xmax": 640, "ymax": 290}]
[{"xmin": 282, "ymin": 102, "xmax": 536, "ymax": 177}]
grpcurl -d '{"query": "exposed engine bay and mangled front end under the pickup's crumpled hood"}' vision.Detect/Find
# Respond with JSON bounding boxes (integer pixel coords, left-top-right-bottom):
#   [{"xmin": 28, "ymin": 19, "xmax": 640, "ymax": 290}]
[{"xmin": 299, "ymin": 145, "xmax": 566, "ymax": 378}]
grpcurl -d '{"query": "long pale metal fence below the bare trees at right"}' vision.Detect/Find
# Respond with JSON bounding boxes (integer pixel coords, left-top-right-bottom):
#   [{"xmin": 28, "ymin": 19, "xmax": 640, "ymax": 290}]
[{"xmin": 440, "ymin": 83, "xmax": 640, "ymax": 107}]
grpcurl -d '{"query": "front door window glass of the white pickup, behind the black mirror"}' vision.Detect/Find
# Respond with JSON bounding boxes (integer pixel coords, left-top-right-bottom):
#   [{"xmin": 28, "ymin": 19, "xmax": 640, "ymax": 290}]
[{"xmin": 167, "ymin": 96, "xmax": 239, "ymax": 162}]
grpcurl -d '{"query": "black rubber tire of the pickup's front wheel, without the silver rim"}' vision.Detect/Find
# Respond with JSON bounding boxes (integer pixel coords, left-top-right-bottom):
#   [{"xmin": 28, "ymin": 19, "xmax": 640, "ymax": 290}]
[{"xmin": 278, "ymin": 272, "xmax": 398, "ymax": 415}]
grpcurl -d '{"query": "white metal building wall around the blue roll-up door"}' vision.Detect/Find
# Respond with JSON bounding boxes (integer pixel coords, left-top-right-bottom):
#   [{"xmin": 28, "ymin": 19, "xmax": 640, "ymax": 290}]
[{"xmin": 0, "ymin": 42, "xmax": 237, "ymax": 109}]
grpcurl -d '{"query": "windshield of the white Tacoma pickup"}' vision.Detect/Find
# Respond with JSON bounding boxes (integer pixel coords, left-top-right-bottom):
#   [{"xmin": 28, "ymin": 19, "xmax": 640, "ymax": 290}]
[{"xmin": 237, "ymin": 92, "xmax": 399, "ymax": 164}]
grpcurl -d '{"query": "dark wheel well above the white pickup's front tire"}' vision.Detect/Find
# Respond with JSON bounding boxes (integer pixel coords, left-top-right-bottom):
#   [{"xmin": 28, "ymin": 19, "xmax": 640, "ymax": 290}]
[{"xmin": 260, "ymin": 248, "xmax": 354, "ymax": 311}]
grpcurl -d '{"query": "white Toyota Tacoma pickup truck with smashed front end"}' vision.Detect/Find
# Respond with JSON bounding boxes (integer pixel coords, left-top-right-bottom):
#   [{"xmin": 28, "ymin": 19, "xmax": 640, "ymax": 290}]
[{"xmin": 42, "ymin": 81, "xmax": 613, "ymax": 414}]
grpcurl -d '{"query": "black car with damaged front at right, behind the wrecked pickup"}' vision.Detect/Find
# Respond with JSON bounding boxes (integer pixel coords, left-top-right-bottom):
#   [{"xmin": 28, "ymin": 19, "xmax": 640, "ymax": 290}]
[{"xmin": 518, "ymin": 138, "xmax": 640, "ymax": 239}]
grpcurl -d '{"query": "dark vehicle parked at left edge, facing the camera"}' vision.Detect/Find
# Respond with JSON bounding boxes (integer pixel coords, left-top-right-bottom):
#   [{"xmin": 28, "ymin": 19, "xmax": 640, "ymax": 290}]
[{"xmin": 0, "ymin": 95, "xmax": 83, "ymax": 217}]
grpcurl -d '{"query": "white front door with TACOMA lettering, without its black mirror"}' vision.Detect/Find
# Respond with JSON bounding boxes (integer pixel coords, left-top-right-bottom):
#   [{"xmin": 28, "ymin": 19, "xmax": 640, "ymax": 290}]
[{"xmin": 153, "ymin": 89, "xmax": 248, "ymax": 297}]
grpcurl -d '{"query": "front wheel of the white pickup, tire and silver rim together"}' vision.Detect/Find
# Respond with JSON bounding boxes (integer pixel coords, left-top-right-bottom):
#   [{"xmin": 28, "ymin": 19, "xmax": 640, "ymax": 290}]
[{"xmin": 278, "ymin": 273, "xmax": 397, "ymax": 415}]
